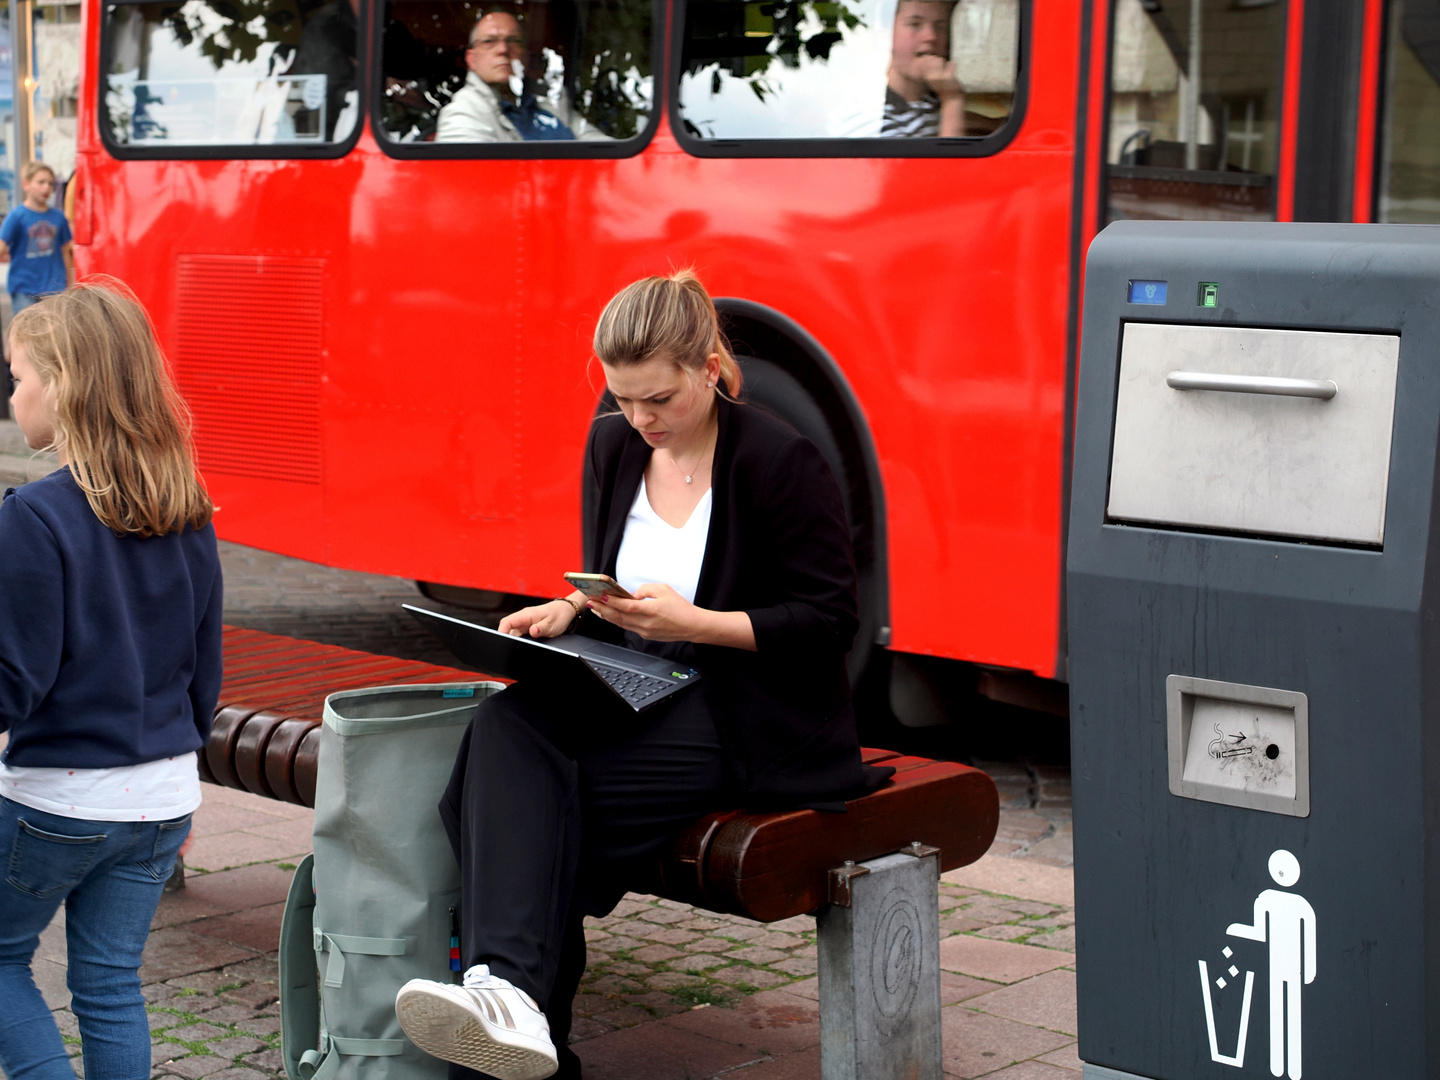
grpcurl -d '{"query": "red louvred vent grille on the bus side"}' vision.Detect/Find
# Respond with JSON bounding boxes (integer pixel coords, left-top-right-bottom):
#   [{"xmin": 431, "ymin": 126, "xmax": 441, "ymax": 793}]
[{"xmin": 174, "ymin": 255, "xmax": 325, "ymax": 484}]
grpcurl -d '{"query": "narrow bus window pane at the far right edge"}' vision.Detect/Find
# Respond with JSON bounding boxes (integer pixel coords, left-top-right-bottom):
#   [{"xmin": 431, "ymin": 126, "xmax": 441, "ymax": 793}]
[{"xmin": 1378, "ymin": 0, "xmax": 1440, "ymax": 225}]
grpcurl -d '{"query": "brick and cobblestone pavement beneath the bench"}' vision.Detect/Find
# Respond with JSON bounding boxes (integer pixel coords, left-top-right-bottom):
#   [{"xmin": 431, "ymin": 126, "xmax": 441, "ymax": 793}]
[{"xmin": 0, "ymin": 443, "xmax": 1080, "ymax": 1080}]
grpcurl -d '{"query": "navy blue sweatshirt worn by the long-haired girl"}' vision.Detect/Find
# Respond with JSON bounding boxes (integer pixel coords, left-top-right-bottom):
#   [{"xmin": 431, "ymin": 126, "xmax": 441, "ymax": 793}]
[{"xmin": 0, "ymin": 468, "xmax": 220, "ymax": 769}]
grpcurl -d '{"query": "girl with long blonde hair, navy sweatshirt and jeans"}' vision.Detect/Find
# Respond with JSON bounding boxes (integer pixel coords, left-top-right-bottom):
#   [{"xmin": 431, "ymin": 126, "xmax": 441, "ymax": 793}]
[{"xmin": 0, "ymin": 282, "xmax": 222, "ymax": 1080}]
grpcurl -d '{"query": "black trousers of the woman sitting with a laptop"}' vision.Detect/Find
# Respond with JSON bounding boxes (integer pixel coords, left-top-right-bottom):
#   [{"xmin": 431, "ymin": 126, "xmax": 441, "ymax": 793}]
[{"xmin": 439, "ymin": 684, "xmax": 733, "ymax": 1080}]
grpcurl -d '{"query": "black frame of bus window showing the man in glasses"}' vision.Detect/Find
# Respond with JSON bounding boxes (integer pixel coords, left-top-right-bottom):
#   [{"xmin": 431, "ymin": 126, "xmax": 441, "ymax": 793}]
[{"xmin": 367, "ymin": 0, "xmax": 668, "ymax": 161}]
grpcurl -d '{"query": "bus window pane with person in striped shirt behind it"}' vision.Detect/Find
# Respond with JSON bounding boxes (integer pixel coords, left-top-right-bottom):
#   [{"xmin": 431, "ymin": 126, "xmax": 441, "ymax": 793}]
[{"xmin": 680, "ymin": 0, "xmax": 1020, "ymax": 140}]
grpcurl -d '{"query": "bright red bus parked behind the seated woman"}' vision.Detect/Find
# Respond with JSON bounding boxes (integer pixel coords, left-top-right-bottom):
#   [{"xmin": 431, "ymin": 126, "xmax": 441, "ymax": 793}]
[{"xmin": 75, "ymin": 0, "xmax": 1440, "ymax": 724}]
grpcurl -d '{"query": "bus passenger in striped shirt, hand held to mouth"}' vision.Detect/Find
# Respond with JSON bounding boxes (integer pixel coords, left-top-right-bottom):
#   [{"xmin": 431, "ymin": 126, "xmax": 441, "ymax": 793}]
[{"xmin": 880, "ymin": 0, "xmax": 965, "ymax": 138}]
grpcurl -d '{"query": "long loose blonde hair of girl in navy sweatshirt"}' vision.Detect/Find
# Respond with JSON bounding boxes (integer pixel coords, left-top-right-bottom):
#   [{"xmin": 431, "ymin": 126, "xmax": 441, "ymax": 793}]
[{"xmin": 10, "ymin": 279, "xmax": 215, "ymax": 537}]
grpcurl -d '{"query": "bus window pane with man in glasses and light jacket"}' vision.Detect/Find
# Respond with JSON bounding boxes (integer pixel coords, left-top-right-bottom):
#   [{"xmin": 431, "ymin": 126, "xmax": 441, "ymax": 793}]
[{"xmin": 380, "ymin": 0, "xmax": 654, "ymax": 145}]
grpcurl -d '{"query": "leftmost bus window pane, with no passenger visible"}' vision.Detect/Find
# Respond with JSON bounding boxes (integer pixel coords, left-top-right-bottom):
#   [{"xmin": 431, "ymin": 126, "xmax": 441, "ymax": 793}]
[{"xmin": 102, "ymin": 0, "xmax": 359, "ymax": 147}]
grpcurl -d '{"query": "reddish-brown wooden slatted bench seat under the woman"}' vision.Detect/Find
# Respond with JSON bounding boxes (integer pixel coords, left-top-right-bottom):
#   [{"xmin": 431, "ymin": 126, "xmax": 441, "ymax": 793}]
[{"xmin": 213, "ymin": 626, "xmax": 999, "ymax": 922}]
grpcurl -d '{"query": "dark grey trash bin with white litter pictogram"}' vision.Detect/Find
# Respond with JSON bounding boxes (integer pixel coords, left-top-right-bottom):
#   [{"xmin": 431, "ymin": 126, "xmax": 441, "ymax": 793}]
[{"xmin": 1067, "ymin": 222, "xmax": 1440, "ymax": 1080}]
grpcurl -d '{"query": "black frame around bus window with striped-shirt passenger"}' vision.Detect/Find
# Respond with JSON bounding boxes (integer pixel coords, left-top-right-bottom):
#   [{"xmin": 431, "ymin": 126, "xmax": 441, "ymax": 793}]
[{"xmin": 668, "ymin": 0, "xmax": 1032, "ymax": 157}]
